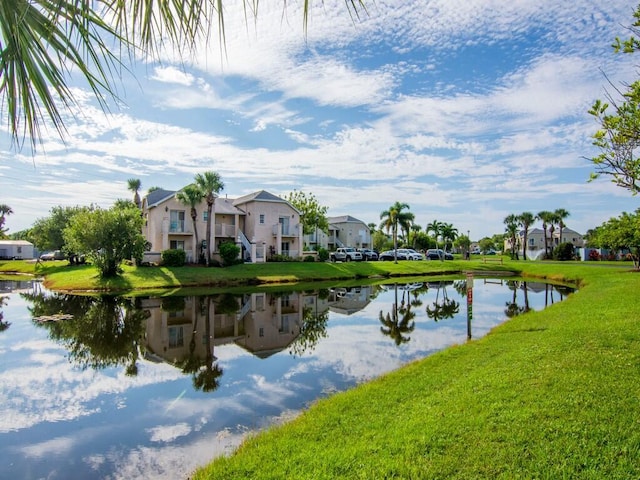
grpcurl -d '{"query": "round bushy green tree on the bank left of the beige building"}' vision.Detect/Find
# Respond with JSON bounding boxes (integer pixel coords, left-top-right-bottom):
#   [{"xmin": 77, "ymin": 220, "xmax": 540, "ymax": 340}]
[{"xmin": 63, "ymin": 206, "xmax": 146, "ymax": 278}]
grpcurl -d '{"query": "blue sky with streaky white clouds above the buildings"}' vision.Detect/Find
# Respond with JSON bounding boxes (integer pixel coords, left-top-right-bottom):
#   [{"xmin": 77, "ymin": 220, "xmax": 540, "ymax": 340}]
[{"xmin": 0, "ymin": 0, "xmax": 640, "ymax": 241}]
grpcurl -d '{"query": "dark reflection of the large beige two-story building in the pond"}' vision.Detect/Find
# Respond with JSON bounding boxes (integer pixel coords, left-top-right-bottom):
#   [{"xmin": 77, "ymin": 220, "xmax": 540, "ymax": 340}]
[{"xmin": 142, "ymin": 292, "xmax": 327, "ymax": 364}]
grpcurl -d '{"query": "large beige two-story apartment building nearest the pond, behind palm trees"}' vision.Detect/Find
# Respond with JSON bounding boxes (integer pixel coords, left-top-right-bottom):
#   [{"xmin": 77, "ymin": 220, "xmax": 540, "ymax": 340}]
[{"xmin": 142, "ymin": 189, "xmax": 302, "ymax": 263}]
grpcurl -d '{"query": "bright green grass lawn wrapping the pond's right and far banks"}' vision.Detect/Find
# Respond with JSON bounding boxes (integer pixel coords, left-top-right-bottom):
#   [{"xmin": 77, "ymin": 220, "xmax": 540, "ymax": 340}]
[{"xmin": 0, "ymin": 259, "xmax": 640, "ymax": 480}]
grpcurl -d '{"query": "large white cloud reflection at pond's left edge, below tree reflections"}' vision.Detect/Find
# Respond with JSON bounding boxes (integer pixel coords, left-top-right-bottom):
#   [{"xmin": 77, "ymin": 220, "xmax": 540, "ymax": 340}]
[{"xmin": 0, "ymin": 354, "xmax": 182, "ymax": 432}]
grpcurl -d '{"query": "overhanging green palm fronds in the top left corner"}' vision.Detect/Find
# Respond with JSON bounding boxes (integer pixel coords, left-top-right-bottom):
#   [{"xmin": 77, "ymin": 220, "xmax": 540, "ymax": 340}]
[{"xmin": 0, "ymin": 0, "xmax": 366, "ymax": 148}]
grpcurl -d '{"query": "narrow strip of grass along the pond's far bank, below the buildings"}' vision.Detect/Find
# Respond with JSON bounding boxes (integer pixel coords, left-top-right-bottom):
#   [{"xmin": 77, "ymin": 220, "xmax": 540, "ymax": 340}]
[{"xmin": 0, "ymin": 258, "xmax": 600, "ymax": 294}]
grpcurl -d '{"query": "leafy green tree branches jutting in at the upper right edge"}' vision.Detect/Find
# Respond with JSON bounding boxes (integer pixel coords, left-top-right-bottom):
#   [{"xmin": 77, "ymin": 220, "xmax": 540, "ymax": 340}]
[{"xmin": 589, "ymin": 6, "xmax": 640, "ymax": 195}]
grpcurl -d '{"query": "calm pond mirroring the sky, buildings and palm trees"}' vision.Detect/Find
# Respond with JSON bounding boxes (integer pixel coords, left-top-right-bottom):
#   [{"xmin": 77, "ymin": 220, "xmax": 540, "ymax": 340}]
[{"xmin": 0, "ymin": 278, "xmax": 572, "ymax": 480}]
